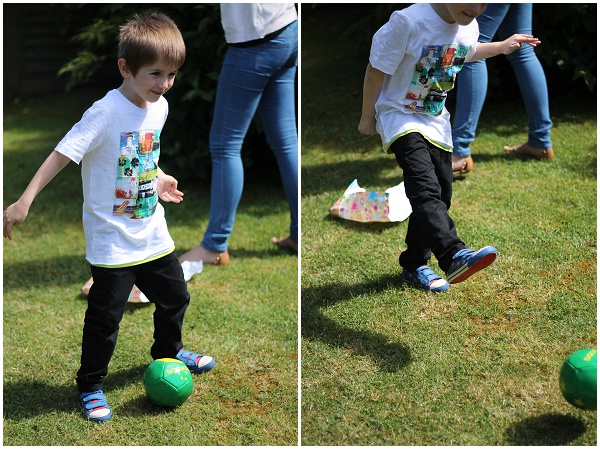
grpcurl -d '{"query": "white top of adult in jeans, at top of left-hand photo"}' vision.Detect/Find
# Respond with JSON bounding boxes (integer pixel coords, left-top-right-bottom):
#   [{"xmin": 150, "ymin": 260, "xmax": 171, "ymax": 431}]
[{"xmin": 221, "ymin": 3, "xmax": 298, "ymax": 44}]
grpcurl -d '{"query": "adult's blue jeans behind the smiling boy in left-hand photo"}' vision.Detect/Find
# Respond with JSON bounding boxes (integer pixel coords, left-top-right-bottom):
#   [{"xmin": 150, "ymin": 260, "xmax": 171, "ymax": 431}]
[{"xmin": 201, "ymin": 22, "xmax": 298, "ymax": 253}]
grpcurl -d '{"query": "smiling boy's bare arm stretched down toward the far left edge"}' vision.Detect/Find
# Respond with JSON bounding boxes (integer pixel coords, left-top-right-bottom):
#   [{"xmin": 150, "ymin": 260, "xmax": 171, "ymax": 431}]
[{"xmin": 4, "ymin": 151, "xmax": 71, "ymax": 240}]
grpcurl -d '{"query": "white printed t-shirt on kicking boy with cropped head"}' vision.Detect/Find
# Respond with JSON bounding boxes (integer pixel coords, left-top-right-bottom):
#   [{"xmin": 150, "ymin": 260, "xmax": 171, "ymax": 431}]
[{"xmin": 369, "ymin": 3, "xmax": 479, "ymax": 151}]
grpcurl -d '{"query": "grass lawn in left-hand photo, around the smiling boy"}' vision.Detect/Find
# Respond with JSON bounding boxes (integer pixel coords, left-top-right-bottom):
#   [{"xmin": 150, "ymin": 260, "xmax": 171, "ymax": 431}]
[{"xmin": 3, "ymin": 86, "xmax": 298, "ymax": 446}]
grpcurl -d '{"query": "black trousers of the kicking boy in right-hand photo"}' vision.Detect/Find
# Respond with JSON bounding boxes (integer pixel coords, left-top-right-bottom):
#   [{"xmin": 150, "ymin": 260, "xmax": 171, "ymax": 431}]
[{"xmin": 390, "ymin": 132, "xmax": 465, "ymax": 272}]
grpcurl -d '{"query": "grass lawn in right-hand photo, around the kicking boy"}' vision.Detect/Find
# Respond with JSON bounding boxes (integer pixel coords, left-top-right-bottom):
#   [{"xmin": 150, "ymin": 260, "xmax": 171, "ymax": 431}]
[{"xmin": 301, "ymin": 6, "xmax": 597, "ymax": 445}]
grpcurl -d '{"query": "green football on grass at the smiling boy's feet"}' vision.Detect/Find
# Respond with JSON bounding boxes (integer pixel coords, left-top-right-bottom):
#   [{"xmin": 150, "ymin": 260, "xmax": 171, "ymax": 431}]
[{"xmin": 144, "ymin": 359, "xmax": 194, "ymax": 407}]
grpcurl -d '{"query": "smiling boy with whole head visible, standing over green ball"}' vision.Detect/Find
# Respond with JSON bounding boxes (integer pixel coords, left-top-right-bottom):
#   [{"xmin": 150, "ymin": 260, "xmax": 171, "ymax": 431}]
[{"xmin": 4, "ymin": 13, "xmax": 215, "ymax": 421}]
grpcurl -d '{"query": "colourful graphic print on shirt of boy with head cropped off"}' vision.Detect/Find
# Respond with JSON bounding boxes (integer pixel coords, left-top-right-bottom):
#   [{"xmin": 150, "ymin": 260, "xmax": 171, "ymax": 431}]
[{"xmin": 404, "ymin": 44, "xmax": 469, "ymax": 115}]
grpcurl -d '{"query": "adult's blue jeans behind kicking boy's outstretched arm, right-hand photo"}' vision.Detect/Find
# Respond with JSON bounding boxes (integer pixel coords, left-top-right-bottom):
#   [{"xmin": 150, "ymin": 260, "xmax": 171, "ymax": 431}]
[{"xmin": 452, "ymin": 3, "xmax": 552, "ymax": 157}]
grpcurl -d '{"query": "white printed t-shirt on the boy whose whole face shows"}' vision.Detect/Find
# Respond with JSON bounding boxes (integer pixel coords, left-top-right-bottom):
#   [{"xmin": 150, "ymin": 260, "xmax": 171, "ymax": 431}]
[{"xmin": 56, "ymin": 89, "xmax": 175, "ymax": 267}]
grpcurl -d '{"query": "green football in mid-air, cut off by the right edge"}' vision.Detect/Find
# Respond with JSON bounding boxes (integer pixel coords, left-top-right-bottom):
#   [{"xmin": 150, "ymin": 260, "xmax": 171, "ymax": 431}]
[{"xmin": 559, "ymin": 349, "xmax": 598, "ymax": 410}]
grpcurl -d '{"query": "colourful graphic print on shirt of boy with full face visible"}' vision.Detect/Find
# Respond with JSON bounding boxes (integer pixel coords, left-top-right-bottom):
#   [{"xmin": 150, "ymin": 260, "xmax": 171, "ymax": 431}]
[{"xmin": 113, "ymin": 129, "xmax": 160, "ymax": 218}]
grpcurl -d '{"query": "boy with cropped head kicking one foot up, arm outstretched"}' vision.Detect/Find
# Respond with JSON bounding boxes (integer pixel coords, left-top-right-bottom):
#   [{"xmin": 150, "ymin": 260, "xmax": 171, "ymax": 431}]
[{"xmin": 358, "ymin": 3, "xmax": 540, "ymax": 293}]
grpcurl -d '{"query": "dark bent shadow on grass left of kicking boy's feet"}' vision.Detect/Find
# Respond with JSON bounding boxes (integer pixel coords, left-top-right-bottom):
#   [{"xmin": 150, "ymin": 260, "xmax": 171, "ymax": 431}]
[{"xmin": 302, "ymin": 276, "xmax": 411, "ymax": 372}]
